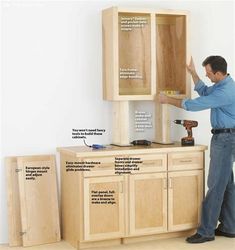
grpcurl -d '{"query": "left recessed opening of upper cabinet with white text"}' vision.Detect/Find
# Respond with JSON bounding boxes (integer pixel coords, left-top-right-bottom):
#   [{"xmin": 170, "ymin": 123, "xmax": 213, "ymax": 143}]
[{"xmin": 118, "ymin": 12, "xmax": 151, "ymax": 95}]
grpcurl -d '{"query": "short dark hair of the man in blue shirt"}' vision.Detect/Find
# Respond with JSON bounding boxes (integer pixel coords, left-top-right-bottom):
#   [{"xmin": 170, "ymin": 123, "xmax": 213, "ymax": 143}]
[{"xmin": 202, "ymin": 56, "xmax": 227, "ymax": 74}]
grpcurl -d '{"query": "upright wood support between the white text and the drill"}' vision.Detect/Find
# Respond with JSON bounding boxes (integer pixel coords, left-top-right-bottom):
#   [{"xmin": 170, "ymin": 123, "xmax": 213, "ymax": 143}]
[{"xmin": 154, "ymin": 101, "xmax": 172, "ymax": 144}]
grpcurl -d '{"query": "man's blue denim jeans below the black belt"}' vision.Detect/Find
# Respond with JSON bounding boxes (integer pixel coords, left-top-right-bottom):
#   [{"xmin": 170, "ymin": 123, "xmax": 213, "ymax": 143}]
[{"xmin": 197, "ymin": 133, "xmax": 235, "ymax": 237}]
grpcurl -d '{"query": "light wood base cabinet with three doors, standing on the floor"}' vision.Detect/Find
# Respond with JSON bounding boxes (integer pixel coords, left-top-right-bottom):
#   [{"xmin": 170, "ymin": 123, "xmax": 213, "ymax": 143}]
[{"xmin": 59, "ymin": 145, "xmax": 206, "ymax": 248}]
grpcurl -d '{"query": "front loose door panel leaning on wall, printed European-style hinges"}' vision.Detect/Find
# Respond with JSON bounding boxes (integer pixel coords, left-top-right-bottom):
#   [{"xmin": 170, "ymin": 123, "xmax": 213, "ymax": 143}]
[{"xmin": 17, "ymin": 155, "xmax": 60, "ymax": 246}]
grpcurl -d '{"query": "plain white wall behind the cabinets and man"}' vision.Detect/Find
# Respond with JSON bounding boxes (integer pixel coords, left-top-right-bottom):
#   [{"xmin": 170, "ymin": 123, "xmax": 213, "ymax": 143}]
[{"xmin": 0, "ymin": 0, "xmax": 235, "ymax": 243}]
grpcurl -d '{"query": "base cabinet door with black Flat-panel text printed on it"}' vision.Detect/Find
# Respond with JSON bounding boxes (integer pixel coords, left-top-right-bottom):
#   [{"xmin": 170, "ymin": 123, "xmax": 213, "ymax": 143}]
[{"xmin": 84, "ymin": 176, "xmax": 124, "ymax": 240}]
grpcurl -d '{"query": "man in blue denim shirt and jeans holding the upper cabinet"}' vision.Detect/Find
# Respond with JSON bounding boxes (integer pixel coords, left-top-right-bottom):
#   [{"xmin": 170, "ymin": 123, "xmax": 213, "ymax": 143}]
[{"xmin": 159, "ymin": 56, "xmax": 235, "ymax": 243}]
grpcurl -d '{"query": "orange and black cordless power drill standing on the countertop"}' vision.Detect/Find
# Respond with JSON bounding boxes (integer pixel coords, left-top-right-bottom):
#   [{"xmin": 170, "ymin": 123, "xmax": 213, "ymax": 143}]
[{"xmin": 174, "ymin": 120, "xmax": 198, "ymax": 146}]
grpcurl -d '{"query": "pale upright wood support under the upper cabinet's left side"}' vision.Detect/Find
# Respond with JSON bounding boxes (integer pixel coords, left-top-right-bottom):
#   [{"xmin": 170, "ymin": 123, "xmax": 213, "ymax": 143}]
[{"xmin": 112, "ymin": 101, "xmax": 130, "ymax": 146}]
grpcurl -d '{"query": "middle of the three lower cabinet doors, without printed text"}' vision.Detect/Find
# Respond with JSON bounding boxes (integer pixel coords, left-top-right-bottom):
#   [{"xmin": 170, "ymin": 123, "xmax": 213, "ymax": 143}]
[{"xmin": 129, "ymin": 173, "xmax": 167, "ymax": 235}]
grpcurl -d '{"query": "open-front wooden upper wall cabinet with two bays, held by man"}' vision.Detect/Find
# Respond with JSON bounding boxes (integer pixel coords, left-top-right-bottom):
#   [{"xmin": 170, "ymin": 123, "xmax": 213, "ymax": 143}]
[{"xmin": 102, "ymin": 7, "xmax": 189, "ymax": 101}]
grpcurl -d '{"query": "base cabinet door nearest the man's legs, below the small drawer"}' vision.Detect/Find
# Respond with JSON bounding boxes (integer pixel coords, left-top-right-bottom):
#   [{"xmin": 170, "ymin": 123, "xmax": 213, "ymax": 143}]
[{"xmin": 168, "ymin": 170, "xmax": 203, "ymax": 231}]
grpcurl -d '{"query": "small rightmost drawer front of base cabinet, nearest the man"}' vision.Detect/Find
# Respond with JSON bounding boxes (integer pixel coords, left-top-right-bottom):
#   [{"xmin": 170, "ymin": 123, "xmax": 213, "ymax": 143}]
[{"xmin": 168, "ymin": 152, "xmax": 203, "ymax": 171}]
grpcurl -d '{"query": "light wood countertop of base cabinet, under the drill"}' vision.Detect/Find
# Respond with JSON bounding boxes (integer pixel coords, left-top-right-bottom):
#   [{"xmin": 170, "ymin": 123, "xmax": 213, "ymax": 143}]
[{"xmin": 57, "ymin": 142, "xmax": 208, "ymax": 157}]
